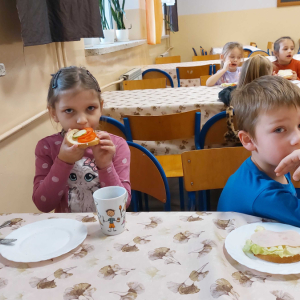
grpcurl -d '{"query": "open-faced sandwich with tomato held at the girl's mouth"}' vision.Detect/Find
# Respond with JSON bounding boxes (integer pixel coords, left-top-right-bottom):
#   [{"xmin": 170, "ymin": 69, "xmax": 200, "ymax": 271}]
[{"xmin": 66, "ymin": 128, "xmax": 100, "ymax": 149}]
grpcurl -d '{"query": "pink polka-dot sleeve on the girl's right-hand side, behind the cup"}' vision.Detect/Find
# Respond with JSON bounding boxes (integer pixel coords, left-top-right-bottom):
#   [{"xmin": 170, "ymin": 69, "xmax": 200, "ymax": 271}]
[{"xmin": 98, "ymin": 136, "xmax": 131, "ymax": 207}]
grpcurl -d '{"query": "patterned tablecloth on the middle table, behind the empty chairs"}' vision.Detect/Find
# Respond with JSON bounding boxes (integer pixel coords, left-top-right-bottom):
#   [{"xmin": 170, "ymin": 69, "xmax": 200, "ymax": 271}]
[{"xmin": 102, "ymin": 86, "xmax": 225, "ymax": 155}]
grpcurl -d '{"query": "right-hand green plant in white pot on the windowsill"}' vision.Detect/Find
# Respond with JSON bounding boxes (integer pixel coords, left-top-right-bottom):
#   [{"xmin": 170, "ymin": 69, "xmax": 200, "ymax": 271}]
[{"xmin": 111, "ymin": 0, "xmax": 129, "ymax": 42}]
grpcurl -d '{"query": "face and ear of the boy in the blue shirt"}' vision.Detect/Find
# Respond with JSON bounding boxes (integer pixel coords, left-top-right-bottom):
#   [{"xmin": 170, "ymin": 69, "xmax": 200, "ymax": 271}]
[{"xmin": 253, "ymin": 107, "xmax": 300, "ymax": 167}]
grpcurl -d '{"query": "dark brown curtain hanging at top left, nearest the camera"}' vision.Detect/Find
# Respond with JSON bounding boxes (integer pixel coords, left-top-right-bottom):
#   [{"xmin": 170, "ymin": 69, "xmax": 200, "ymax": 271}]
[{"xmin": 17, "ymin": 0, "xmax": 103, "ymax": 46}]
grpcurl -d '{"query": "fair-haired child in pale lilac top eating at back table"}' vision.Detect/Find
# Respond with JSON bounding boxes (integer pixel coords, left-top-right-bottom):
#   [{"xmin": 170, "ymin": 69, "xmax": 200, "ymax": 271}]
[{"xmin": 206, "ymin": 42, "xmax": 244, "ymax": 86}]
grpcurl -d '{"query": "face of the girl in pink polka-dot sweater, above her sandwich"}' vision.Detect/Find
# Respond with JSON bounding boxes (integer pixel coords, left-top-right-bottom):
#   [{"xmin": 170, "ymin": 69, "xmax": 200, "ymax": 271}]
[{"xmin": 50, "ymin": 89, "xmax": 102, "ymax": 131}]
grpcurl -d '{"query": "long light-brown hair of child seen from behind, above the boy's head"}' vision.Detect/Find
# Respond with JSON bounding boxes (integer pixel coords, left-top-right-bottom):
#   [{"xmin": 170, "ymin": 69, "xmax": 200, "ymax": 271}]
[{"xmin": 238, "ymin": 55, "xmax": 273, "ymax": 87}]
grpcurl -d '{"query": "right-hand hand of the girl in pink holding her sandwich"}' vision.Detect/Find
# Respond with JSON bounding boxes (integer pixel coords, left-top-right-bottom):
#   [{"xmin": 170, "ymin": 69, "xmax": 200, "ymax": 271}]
[{"xmin": 92, "ymin": 131, "xmax": 116, "ymax": 169}]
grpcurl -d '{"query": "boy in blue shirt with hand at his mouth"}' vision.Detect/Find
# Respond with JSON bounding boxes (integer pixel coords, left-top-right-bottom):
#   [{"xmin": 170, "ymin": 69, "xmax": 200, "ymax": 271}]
[{"xmin": 218, "ymin": 76, "xmax": 300, "ymax": 227}]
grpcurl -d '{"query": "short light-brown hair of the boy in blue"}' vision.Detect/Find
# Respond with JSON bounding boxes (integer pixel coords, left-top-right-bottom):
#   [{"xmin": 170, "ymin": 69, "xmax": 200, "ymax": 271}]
[{"xmin": 231, "ymin": 76, "xmax": 300, "ymax": 139}]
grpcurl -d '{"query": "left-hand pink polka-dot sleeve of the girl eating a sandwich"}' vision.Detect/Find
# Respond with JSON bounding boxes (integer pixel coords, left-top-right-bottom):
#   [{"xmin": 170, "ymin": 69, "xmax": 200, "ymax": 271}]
[{"xmin": 32, "ymin": 140, "xmax": 73, "ymax": 212}]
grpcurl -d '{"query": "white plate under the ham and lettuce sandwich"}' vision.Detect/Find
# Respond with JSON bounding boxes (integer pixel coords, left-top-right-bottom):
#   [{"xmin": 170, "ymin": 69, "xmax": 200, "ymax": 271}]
[{"xmin": 225, "ymin": 223, "xmax": 300, "ymax": 275}]
